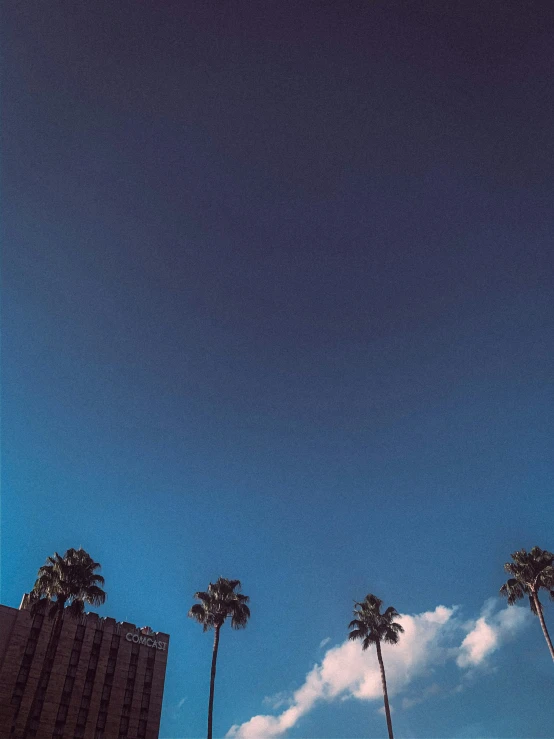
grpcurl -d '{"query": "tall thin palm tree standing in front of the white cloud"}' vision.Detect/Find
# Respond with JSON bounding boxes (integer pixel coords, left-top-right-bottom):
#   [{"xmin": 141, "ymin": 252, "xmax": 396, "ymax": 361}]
[{"xmin": 348, "ymin": 593, "xmax": 404, "ymax": 739}]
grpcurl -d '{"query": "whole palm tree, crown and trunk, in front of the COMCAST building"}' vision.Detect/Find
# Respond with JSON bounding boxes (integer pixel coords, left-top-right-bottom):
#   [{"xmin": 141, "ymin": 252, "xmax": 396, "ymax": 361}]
[{"xmin": 22, "ymin": 548, "xmax": 106, "ymax": 728}]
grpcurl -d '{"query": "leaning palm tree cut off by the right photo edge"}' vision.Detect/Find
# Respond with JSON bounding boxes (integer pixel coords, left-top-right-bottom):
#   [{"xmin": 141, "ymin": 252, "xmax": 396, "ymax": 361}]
[{"xmin": 500, "ymin": 547, "xmax": 554, "ymax": 660}]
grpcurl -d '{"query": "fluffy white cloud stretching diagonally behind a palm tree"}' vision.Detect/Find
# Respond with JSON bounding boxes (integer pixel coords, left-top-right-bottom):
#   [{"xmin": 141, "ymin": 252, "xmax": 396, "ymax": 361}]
[{"xmin": 226, "ymin": 603, "xmax": 526, "ymax": 739}]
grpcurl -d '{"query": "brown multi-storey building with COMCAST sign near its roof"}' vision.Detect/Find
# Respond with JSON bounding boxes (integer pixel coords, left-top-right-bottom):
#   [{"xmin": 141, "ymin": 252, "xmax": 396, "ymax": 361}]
[{"xmin": 0, "ymin": 596, "xmax": 169, "ymax": 739}]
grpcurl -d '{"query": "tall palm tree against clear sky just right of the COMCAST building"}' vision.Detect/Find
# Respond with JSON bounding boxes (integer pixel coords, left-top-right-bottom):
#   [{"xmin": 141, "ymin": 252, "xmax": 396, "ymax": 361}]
[{"xmin": 188, "ymin": 577, "xmax": 250, "ymax": 739}]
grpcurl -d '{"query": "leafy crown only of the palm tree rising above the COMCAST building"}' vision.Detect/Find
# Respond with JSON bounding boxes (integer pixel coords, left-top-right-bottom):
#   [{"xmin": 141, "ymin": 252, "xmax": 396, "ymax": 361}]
[{"xmin": 30, "ymin": 549, "xmax": 106, "ymax": 618}]
